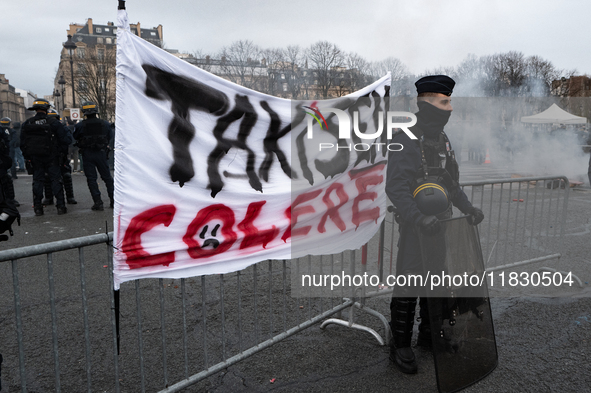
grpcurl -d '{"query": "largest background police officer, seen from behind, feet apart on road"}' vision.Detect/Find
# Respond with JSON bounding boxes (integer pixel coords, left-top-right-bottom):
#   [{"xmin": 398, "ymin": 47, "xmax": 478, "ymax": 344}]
[{"xmin": 21, "ymin": 99, "xmax": 72, "ymax": 216}]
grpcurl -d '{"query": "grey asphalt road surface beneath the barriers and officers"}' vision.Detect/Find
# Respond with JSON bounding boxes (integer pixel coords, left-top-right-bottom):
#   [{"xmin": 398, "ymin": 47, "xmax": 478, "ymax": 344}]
[{"xmin": 0, "ymin": 168, "xmax": 591, "ymax": 393}]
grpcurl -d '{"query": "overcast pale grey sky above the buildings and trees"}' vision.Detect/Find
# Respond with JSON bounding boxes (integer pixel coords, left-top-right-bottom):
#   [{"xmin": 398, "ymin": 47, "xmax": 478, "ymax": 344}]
[{"xmin": 0, "ymin": 0, "xmax": 591, "ymax": 96}]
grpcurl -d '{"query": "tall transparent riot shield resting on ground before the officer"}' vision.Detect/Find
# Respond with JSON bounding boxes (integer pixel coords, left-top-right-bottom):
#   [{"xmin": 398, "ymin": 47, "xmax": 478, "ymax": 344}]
[{"xmin": 419, "ymin": 217, "xmax": 498, "ymax": 393}]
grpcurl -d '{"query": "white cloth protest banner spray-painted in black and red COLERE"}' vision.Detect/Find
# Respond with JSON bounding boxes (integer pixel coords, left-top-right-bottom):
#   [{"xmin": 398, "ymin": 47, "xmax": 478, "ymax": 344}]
[{"xmin": 114, "ymin": 10, "xmax": 395, "ymax": 288}]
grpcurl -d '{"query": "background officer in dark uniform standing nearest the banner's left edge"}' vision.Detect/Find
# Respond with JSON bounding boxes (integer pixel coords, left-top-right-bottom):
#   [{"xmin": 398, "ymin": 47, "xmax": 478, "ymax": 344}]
[{"xmin": 74, "ymin": 101, "xmax": 114, "ymax": 211}]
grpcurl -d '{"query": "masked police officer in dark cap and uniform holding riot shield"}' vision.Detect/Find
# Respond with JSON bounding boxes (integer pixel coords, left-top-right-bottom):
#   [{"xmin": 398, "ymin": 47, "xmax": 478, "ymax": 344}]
[{"xmin": 386, "ymin": 75, "xmax": 484, "ymax": 374}]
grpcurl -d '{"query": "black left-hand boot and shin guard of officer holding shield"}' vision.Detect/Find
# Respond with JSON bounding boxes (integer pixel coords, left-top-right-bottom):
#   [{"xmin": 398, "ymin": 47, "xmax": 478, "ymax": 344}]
[{"xmin": 390, "ymin": 298, "xmax": 418, "ymax": 374}]
